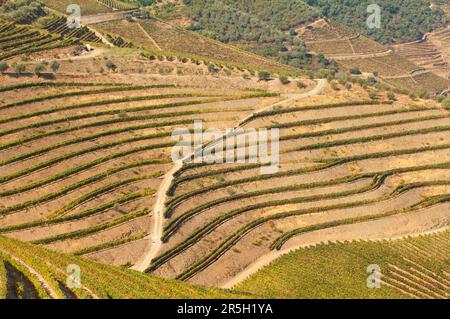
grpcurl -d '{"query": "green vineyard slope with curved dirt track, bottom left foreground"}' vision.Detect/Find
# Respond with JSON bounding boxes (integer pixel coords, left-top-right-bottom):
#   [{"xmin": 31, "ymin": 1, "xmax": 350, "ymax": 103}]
[{"xmin": 0, "ymin": 237, "xmax": 243, "ymax": 299}]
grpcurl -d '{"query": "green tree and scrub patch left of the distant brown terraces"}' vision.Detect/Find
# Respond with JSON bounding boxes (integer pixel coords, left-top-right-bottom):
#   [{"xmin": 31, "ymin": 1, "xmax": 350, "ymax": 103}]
[{"xmin": 184, "ymin": 0, "xmax": 336, "ymax": 69}]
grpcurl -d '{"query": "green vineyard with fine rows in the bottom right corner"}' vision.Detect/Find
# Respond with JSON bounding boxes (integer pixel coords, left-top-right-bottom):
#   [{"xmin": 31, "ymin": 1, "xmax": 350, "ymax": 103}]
[{"xmin": 235, "ymin": 230, "xmax": 450, "ymax": 299}]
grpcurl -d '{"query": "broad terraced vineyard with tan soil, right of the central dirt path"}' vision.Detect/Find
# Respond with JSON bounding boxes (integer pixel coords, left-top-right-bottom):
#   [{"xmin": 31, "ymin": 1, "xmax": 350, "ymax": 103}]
[{"xmin": 149, "ymin": 94, "xmax": 450, "ymax": 286}]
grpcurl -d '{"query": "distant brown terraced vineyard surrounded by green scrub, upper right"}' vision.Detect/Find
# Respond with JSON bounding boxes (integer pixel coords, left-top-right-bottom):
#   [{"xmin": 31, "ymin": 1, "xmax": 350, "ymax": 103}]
[{"xmin": 298, "ymin": 20, "xmax": 450, "ymax": 95}]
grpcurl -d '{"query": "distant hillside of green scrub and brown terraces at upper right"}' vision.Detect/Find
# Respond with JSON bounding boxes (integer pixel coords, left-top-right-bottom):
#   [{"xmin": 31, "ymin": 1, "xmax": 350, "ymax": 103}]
[{"xmin": 138, "ymin": 0, "xmax": 449, "ymax": 96}]
